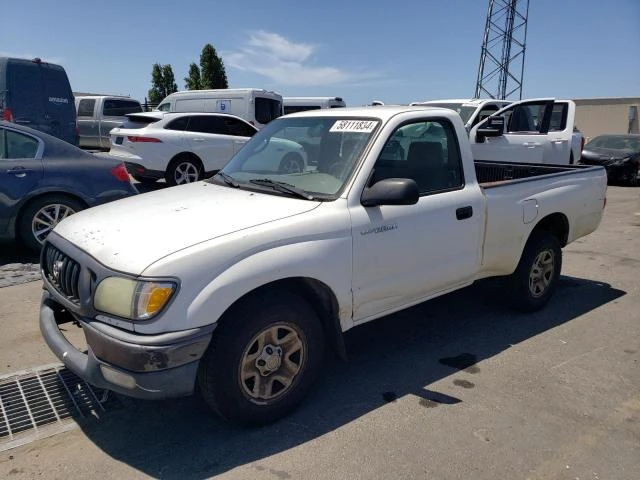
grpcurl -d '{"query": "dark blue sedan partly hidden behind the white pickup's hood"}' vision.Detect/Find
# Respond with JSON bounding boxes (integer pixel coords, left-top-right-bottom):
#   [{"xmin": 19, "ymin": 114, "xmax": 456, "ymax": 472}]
[{"xmin": 0, "ymin": 121, "xmax": 138, "ymax": 250}]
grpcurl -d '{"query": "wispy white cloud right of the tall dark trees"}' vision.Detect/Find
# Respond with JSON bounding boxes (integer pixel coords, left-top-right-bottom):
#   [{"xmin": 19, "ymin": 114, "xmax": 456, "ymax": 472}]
[{"xmin": 223, "ymin": 30, "xmax": 379, "ymax": 86}]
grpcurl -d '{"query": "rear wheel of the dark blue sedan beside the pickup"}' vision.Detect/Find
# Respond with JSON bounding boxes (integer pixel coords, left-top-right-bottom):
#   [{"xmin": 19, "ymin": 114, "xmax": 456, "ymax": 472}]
[{"xmin": 18, "ymin": 195, "xmax": 86, "ymax": 252}]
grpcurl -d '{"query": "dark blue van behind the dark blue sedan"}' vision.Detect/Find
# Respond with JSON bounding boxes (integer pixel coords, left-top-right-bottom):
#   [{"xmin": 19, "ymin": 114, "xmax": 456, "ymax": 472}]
[{"xmin": 0, "ymin": 57, "xmax": 78, "ymax": 145}]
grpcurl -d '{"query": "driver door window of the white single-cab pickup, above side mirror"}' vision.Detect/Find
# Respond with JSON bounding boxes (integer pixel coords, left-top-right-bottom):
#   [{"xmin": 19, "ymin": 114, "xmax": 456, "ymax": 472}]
[{"xmin": 370, "ymin": 120, "xmax": 463, "ymax": 195}]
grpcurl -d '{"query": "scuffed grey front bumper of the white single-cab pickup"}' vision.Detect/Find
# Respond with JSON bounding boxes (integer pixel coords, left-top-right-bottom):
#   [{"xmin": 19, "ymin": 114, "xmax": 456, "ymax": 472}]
[{"xmin": 40, "ymin": 291, "xmax": 215, "ymax": 399}]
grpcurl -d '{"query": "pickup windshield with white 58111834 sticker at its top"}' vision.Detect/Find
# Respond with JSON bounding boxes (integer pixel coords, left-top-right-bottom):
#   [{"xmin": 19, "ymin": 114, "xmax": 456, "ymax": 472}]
[{"xmin": 212, "ymin": 116, "xmax": 380, "ymax": 200}]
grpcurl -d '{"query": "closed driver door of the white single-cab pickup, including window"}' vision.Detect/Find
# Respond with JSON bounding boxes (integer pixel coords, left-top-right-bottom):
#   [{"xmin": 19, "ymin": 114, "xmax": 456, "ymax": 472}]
[{"xmin": 350, "ymin": 119, "xmax": 484, "ymax": 323}]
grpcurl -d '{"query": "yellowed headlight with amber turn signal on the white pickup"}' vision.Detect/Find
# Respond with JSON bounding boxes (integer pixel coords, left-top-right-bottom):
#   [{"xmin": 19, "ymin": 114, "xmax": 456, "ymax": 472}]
[{"xmin": 93, "ymin": 277, "xmax": 176, "ymax": 320}]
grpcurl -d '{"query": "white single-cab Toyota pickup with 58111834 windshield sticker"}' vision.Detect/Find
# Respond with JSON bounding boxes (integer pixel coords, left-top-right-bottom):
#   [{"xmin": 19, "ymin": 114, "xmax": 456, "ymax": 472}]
[{"xmin": 40, "ymin": 106, "xmax": 606, "ymax": 424}]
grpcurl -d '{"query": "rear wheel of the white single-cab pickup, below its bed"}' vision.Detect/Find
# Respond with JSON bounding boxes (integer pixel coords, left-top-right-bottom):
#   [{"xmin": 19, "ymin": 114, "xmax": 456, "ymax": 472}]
[{"xmin": 508, "ymin": 231, "xmax": 562, "ymax": 312}]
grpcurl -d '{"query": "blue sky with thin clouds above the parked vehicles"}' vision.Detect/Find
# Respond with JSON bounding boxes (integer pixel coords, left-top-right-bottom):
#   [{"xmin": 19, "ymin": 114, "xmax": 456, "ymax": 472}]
[{"xmin": 0, "ymin": 0, "xmax": 640, "ymax": 105}]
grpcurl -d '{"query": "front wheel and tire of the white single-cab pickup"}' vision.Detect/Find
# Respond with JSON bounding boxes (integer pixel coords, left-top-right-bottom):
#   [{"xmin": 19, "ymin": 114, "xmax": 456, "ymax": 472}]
[{"xmin": 198, "ymin": 291, "xmax": 324, "ymax": 426}]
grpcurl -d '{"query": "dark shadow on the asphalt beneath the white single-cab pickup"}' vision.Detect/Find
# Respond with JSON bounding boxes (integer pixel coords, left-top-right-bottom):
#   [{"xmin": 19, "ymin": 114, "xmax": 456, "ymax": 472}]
[{"xmin": 76, "ymin": 277, "xmax": 626, "ymax": 479}]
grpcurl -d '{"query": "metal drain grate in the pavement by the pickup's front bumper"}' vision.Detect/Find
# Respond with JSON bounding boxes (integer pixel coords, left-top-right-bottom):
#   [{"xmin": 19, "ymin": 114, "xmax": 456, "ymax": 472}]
[{"xmin": 0, "ymin": 365, "xmax": 108, "ymax": 452}]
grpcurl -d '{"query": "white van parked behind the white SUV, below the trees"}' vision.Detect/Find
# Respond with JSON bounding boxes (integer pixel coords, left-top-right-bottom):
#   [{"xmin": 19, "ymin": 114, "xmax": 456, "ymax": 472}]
[{"xmin": 158, "ymin": 88, "xmax": 282, "ymax": 128}]
